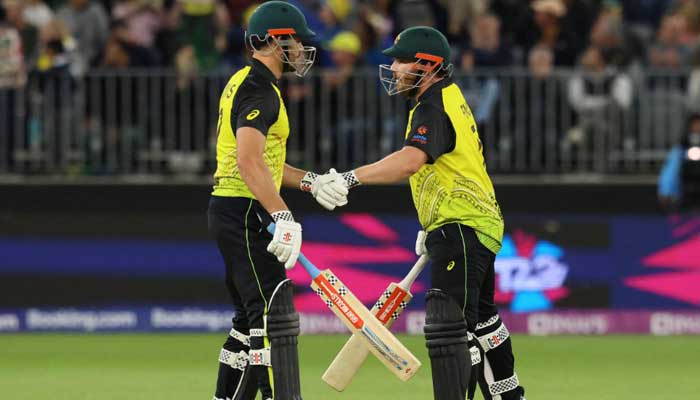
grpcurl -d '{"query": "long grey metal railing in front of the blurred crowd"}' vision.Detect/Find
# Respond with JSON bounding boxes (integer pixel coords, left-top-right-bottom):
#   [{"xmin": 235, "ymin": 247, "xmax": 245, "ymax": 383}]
[{"xmin": 0, "ymin": 68, "xmax": 692, "ymax": 177}]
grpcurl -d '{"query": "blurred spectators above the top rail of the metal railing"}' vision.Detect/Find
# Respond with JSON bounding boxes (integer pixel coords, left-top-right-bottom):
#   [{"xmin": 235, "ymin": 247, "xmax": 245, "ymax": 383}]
[{"xmin": 0, "ymin": 0, "xmax": 700, "ymax": 85}]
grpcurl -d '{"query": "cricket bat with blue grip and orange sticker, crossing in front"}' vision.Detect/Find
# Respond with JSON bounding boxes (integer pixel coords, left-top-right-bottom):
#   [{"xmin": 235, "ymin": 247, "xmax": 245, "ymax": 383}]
[{"xmin": 267, "ymin": 224, "xmax": 421, "ymax": 381}]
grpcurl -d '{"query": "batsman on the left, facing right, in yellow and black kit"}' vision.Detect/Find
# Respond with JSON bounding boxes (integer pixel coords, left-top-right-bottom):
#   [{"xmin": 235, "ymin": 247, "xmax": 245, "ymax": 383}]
[{"xmin": 208, "ymin": 1, "xmax": 347, "ymax": 400}]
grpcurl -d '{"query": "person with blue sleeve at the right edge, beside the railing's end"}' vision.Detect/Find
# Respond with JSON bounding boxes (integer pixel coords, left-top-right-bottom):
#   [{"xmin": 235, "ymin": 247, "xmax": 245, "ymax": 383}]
[{"xmin": 658, "ymin": 114, "xmax": 700, "ymax": 210}]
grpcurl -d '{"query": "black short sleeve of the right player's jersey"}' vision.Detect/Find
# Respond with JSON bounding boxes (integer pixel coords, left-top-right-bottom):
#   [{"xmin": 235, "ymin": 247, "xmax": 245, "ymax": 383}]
[{"xmin": 404, "ymin": 104, "xmax": 455, "ymax": 164}]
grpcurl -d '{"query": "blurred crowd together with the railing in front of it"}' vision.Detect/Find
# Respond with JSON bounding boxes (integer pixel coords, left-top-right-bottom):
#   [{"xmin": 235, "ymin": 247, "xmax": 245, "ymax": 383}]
[{"xmin": 0, "ymin": 0, "xmax": 700, "ymax": 195}]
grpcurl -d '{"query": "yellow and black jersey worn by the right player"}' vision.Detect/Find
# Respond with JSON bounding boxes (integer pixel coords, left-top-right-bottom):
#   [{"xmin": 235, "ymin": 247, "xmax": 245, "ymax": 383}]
[{"xmin": 404, "ymin": 79, "xmax": 503, "ymax": 253}]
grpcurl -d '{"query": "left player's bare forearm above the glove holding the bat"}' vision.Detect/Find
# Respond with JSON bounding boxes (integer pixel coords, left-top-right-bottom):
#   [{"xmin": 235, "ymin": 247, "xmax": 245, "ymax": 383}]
[{"xmin": 238, "ymin": 157, "xmax": 288, "ymax": 214}]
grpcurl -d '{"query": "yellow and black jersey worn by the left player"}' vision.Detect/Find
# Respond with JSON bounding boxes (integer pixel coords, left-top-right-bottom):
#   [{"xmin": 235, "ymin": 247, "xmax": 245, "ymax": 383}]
[{"xmin": 212, "ymin": 59, "xmax": 289, "ymax": 199}]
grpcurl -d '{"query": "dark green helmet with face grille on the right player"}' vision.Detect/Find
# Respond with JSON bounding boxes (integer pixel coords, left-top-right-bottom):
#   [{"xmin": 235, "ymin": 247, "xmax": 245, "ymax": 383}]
[{"xmin": 379, "ymin": 26, "xmax": 453, "ymax": 96}]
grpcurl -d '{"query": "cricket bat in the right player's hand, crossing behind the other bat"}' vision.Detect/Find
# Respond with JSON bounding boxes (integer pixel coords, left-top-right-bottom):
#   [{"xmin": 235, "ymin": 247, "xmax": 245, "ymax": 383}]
[{"xmin": 322, "ymin": 254, "xmax": 428, "ymax": 392}]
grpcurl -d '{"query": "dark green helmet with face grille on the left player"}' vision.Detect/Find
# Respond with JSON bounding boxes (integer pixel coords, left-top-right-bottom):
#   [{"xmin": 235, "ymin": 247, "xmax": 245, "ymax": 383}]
[{"xmin": 245, "ymin": 1, "xmax": 316, "ymax": 76}]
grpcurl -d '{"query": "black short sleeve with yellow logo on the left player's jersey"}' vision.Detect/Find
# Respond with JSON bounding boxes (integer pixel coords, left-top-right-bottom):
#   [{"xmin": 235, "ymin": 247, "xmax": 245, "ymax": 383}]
[{"xmin": 231, "ymin": 82, "xmax": 280, "ymax": 135}]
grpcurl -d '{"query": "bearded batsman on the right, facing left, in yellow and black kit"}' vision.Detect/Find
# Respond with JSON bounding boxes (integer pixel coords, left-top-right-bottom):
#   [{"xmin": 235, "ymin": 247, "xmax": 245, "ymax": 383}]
[{"xmin": 318, "ymin": 26, "xmax": 525, "ymax": 400}]
